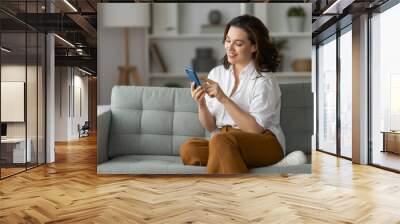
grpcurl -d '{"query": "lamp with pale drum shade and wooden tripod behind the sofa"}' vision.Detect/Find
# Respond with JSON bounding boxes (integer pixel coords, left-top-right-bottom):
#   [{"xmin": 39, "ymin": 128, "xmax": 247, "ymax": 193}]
[{"xmin": 103, "ymin": 3, "xmax": 150, "ymax": 85}]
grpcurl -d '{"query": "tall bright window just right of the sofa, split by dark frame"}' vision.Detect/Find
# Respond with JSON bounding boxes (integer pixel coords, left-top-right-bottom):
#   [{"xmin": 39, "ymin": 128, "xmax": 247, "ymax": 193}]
[{"xmin": 317, "ymin": 25, "xmax": 353, "ymax": 158}]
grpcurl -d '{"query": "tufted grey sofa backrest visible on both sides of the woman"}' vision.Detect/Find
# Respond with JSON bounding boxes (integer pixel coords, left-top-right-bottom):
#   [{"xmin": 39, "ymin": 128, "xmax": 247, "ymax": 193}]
[{"xmin": 109, "ymin": 84, "xmax": 313, "ymax": 157}]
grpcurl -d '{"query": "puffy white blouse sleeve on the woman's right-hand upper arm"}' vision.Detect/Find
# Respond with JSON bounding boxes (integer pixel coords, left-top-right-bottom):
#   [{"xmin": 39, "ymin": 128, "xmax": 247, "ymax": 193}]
[{"xmin": 249, "ymin": 77, "xmax": 281, "ymax": 129}]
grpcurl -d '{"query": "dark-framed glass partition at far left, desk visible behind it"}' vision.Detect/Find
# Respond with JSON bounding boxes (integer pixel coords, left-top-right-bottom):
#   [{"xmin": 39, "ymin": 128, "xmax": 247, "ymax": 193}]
[{"xmin": 0, "ymin": 1, "xmax": 46, "ymax": 178}]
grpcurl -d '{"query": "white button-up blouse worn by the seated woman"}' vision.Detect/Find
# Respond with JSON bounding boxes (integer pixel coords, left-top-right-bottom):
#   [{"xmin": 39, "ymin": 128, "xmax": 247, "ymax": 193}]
[{"xmin": 205, "ymin": 61, "xmax": 285, "ymax": 153}]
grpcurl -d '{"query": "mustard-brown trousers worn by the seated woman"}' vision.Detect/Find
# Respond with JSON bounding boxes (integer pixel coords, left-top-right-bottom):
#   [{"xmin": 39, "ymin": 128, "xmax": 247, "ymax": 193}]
[{"xmin": 179, "ymin": 126, "xmax": 284, "ymax": 174}]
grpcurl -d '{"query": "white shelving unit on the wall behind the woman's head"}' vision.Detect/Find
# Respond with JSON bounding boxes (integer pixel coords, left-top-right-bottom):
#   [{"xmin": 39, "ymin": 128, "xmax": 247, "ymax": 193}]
[{"xmin": 147, "ymin": 3, "xmax": 311, "ymax": 87}]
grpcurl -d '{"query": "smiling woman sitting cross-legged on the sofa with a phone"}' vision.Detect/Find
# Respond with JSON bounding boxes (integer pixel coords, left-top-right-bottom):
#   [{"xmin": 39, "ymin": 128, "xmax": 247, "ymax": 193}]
[{"xmin": 180, "ymin": 15, "xmax": 285, "ymax": 174}]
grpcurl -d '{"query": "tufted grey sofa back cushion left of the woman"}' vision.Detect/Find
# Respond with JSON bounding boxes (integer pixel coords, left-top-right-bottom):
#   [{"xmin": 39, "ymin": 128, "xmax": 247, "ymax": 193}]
[{"xmin": 109, "ymin": 86, "xmax": 206, "ymax": 157}]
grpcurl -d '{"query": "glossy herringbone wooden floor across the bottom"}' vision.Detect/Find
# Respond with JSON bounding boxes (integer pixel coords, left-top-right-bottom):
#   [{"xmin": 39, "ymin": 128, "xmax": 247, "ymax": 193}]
[{"xmin": 0, "ymin": 134, "xmax": 400, "ymax": 224}]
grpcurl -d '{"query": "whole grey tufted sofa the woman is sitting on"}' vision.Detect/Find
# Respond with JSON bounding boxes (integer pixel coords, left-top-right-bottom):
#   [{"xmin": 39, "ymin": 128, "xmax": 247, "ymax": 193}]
[{"xmin": 97, "ymin": 83, "xmax": 313, "ymax": 174}]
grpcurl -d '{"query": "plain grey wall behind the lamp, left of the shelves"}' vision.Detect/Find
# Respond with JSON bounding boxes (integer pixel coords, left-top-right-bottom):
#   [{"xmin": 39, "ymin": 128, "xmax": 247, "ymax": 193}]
[{"xmin": 97, "ymin": 4, "xmax": 147, "ymax": 105}]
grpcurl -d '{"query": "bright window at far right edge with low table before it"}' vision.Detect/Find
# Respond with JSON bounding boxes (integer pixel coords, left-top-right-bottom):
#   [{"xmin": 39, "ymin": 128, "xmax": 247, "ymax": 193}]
[{"xmin": 370, "ymin": 1, "xmax": 400, "ymax": 170}]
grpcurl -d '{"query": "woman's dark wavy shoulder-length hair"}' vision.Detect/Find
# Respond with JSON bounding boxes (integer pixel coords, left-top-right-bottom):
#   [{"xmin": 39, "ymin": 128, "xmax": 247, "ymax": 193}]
[{"xmin": 222, "ymin": 15, "xmax": 281, "ymax": 73}]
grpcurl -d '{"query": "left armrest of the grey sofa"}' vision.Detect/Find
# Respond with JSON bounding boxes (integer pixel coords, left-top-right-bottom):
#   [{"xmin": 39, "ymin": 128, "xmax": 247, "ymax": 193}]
[{"xmin": 97, "ymin": 106, "xmax": 111, "ymax": 164}]
